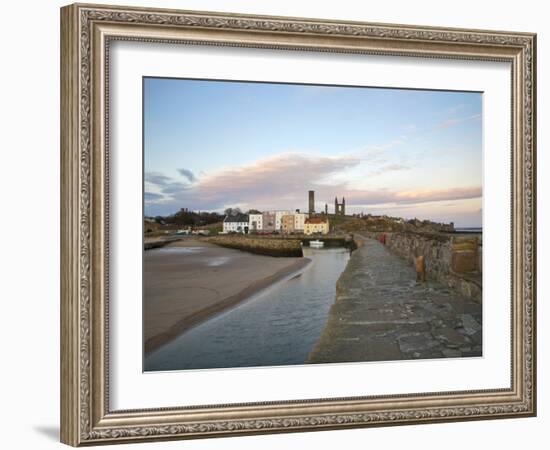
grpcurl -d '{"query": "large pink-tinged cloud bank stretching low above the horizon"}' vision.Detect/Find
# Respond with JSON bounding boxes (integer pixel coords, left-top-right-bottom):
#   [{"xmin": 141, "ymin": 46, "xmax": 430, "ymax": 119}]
[{"xmin": 143, "ymin": 153, "xmax": 481, "ymax": 214}]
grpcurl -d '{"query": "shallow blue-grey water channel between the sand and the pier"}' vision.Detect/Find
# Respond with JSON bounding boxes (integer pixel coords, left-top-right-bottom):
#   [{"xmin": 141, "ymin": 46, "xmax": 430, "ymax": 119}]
[{"xmin": 145, "ymin": 248, "xmax": 349, "ymax": 371}]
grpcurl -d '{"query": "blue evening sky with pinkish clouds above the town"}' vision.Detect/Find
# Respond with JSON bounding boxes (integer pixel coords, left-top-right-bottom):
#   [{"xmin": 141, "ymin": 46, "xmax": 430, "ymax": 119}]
[{"xmin": 143, "ymin": 77, "xmax": 482, "ymax": 227}]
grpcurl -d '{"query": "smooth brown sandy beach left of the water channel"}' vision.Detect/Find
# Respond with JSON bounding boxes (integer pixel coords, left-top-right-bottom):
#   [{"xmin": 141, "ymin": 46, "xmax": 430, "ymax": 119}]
[{"xmin": 143, "ymin": 238, "xmax": 309, "ymax": 353}]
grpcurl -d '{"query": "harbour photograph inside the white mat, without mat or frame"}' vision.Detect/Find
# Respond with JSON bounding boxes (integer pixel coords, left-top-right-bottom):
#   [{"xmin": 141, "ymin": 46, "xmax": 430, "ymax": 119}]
[{"xmin": 142, "ymin": 76, "xmax": 484, "ymax": 372}]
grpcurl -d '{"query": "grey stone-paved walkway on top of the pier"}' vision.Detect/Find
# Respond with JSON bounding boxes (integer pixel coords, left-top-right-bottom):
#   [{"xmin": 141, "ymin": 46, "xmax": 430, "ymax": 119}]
[{"xmin": 308, "ymin": 239, "xmax": 482, "ymax": 363}]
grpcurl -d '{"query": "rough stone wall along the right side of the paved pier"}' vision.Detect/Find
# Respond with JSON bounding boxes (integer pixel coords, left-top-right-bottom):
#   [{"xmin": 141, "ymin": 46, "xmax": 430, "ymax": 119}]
[{"xmin": 370, "ymin": 232, "xmax": 483, "ymax": 302}]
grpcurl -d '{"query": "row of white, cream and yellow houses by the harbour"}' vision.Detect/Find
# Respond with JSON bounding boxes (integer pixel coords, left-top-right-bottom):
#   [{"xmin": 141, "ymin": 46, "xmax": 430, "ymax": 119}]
[{"xmin": 223, "ymin": 210, "xmax": 329, "ymax": 234}]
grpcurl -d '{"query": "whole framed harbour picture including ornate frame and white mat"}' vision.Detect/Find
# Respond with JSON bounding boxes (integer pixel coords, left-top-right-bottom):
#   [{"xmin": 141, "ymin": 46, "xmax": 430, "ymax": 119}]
[{"xmin": 61, "ymin": 4, "xmax": 536, "ymax": 446}]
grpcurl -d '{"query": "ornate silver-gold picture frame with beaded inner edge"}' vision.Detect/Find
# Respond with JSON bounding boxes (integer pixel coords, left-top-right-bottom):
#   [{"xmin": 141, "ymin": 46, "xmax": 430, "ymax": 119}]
[{"xmin": 61, "ymin": 4, "xmax": 536, "ymax": 446}]
